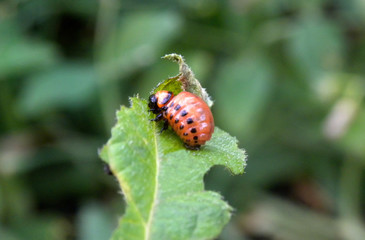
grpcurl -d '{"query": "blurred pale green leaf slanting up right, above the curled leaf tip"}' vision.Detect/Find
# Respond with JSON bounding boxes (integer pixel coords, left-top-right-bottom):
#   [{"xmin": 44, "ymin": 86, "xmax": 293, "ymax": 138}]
[{"xmin": 98, "ymin": 11, "xmax": 180, "ymax": 80}]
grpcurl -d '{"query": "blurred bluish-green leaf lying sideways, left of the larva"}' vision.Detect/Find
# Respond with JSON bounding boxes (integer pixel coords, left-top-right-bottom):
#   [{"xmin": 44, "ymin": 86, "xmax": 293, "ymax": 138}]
[{"xmin": 18, "ymin": 63, "xmax": 97, "ymax": 116}]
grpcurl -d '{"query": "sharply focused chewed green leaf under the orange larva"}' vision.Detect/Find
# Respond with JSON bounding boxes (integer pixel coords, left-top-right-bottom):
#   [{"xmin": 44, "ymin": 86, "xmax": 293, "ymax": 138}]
[{"xmin": 100, "ymin": 54, "xmax": 246, "ymax": 240}]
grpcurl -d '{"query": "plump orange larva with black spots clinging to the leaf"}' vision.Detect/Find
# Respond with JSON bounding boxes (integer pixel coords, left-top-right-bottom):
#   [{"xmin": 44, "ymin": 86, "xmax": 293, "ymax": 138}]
[{"xmin": 150, "ymin": 91, "xmax": 214, "ymax": 149}]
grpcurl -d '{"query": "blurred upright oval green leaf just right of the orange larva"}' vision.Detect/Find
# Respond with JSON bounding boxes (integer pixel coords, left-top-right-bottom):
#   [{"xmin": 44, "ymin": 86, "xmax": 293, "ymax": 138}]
[{"xmin": 214, "ymin": 55, "xmax": 273, "ymax": 138}]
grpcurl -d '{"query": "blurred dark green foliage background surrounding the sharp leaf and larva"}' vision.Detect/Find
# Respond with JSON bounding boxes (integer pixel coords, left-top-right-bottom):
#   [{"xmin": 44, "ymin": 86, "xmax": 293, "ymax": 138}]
[{"xmin": 0, "ymin": 0, "xmax": 365, "ymax": 240}]
